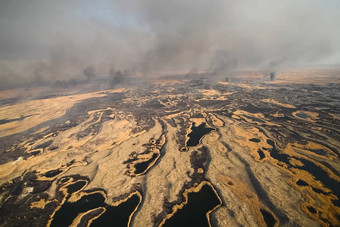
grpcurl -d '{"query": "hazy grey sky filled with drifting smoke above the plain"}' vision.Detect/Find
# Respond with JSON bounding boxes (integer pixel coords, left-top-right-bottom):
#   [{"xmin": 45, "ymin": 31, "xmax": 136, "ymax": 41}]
[{"xmin": 0, "ymin": 0, "xmax": 340, "ymax": 83}]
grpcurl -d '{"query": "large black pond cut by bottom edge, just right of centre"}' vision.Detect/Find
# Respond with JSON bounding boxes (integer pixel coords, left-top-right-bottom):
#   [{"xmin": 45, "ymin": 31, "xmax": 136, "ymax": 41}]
[{"xmin": 163, "ymin": 185, "xmax": 220, "ymax": 227}]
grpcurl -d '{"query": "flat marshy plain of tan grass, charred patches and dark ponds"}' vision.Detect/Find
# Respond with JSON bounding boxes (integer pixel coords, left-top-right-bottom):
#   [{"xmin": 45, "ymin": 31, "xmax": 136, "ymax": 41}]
[{"xmin": 0, "ymin": 69, "xmax": 340, "ymax": 227}]
